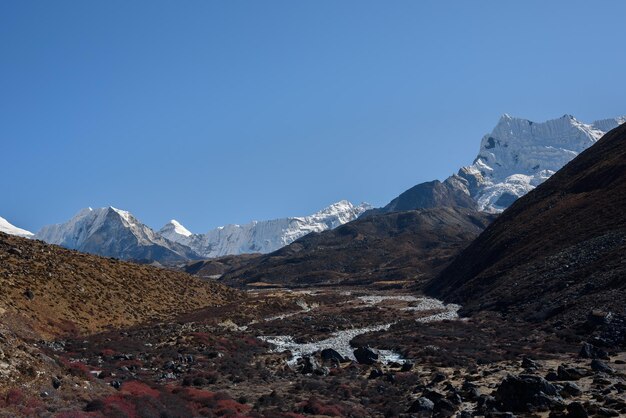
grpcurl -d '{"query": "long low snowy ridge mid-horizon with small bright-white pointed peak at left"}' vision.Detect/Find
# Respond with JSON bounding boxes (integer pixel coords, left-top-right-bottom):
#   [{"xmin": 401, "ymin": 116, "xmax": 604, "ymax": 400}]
[{"xmin": 159, "ymin": 200, "xmax": 370, "ymax": 258}]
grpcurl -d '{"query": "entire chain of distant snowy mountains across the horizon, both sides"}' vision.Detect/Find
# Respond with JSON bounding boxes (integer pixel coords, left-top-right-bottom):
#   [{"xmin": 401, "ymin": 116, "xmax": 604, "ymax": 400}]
[{"xmin": 0, "ymin": 115, "xmax": 626, "ymax": 263}]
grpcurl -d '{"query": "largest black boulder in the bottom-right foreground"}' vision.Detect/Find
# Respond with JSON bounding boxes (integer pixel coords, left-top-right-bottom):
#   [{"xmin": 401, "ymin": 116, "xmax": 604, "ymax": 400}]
[{"xmin": 495, "ymin": 375, "xmax": 558, "ymax": 412}]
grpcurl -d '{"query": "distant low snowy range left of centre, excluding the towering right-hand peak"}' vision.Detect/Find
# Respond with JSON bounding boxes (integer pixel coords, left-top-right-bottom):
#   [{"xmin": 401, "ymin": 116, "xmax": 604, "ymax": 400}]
[{"xmin": 29, "ymin": 200, "xmax": 370, "ymax": 264}]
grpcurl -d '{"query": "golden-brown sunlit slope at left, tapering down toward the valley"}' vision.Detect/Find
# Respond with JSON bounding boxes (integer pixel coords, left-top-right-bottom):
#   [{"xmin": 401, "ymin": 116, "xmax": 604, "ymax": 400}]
[{"xmin": 0, "ymin": 233, "xmax": 239, "ymax": 334}]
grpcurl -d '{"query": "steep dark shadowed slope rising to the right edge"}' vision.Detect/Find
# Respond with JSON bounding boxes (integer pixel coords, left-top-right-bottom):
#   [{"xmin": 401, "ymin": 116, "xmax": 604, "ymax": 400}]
[{"xmin": 426, "ymin": 121, "xmax": 626, "ymax": 321}]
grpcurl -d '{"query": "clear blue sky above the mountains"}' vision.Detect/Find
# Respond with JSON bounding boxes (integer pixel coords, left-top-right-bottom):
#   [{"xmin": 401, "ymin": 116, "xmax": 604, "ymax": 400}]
[{"xmin": 0, "ymin": 0, "xmax": 626, "ymax": 232}]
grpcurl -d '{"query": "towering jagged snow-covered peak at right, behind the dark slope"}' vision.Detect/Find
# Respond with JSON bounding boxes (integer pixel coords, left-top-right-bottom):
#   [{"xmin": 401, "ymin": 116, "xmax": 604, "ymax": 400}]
[{"xmin": 454, "ymin": 114, "xmax": 626, "ymax": 212}]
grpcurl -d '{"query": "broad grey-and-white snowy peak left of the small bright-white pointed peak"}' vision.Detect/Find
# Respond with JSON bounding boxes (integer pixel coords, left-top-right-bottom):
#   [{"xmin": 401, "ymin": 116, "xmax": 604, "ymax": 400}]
[{"xmin": 35, "ymin": 207, "xmax": 197, "ymax": 262}]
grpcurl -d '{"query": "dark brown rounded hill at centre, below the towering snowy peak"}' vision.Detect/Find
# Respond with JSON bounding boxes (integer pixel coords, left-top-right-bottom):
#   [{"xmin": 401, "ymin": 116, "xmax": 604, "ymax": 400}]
[{"xmin": 222, "ymin": 208, "xmax": 493, "ymax": 286}]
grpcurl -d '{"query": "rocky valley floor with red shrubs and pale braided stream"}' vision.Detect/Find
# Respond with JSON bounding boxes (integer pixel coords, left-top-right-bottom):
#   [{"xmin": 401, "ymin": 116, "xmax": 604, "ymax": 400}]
[{"xmin": 0, "ymin": 287, "xmax": 626, "ymax": 417}]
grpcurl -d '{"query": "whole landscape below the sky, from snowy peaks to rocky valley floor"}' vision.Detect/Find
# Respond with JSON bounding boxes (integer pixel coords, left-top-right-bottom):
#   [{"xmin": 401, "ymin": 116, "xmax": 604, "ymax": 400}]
[{"xmin": 0, "ymin": 115, "xmax": 626, "ymax": 418}]
